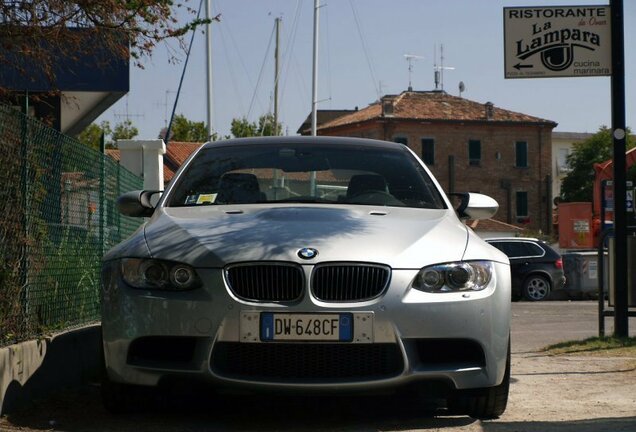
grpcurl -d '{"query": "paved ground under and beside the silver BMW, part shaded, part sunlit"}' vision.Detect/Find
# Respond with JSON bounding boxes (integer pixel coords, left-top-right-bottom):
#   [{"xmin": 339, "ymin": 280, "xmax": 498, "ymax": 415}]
[{"xmin": 0, "ymin": 302, "xmax": 636, "ymax": 432}]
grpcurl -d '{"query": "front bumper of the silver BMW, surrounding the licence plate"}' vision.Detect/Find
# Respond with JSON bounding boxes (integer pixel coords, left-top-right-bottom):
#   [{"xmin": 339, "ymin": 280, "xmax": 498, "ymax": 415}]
[{"xmin": 102, "ymin": 263, "xmax": 510, "ymax": 391}]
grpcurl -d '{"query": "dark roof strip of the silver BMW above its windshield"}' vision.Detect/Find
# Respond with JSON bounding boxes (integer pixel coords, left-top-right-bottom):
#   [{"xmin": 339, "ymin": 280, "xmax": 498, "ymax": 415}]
[{"xmin": 203, "ymin": 136, "xmax": 405, "ymax": 149}]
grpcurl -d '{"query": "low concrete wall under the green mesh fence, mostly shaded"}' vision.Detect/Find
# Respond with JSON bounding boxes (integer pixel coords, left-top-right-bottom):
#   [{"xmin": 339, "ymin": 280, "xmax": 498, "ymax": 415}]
[{"xmin": 0, "ymin": 324, "xmax": 103, "ymax": 415}]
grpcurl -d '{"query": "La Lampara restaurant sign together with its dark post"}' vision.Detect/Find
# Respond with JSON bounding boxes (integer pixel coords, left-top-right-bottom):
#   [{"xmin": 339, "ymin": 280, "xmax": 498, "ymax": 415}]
[{"xmin": 503, "ymin": 0, "xmax": 634, "ymax": 337}]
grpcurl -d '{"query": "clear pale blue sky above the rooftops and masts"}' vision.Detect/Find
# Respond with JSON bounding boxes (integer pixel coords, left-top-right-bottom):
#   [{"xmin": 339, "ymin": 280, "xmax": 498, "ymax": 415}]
[{"xmin": 97, "ymin": 0, "xmax": 636, "ymax": 139}]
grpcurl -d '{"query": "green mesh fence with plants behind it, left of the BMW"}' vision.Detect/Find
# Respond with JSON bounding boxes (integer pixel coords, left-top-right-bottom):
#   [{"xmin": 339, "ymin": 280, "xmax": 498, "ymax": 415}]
[{"xmin": 0, "ymin": 105, "xmax": 143, "ymax": 346}]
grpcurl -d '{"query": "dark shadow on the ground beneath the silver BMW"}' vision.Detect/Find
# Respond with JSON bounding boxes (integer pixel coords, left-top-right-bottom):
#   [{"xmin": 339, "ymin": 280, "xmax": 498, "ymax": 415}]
[{"xmin": 0, "ymin": 385, "xmax": 476, "ymax": 432}]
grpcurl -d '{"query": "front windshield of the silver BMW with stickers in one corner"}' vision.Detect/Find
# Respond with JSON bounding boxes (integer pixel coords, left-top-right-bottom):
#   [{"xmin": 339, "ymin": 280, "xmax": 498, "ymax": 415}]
[{"xmin": 166, "ymin": 143, "xmax": 446, "ymax": 209}]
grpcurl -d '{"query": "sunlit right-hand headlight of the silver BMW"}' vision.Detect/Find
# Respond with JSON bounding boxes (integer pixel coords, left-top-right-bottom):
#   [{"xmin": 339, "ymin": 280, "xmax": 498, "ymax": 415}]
[{"xmin": 412, "ymin": 261, "xmax": 494, "ymax": 293}]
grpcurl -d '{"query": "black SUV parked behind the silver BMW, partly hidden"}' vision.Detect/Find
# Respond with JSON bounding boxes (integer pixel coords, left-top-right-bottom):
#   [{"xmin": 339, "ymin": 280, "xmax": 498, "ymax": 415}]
[{"xmin": 485, "ymin": 237, "xmax": 565, "ymax": 301}]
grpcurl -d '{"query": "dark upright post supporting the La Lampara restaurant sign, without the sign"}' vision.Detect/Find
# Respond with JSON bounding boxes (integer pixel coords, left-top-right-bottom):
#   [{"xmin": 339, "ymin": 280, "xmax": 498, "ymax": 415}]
[{"xmin": 610, "ymin": 0, "xmax": 629, "ymax": 337}]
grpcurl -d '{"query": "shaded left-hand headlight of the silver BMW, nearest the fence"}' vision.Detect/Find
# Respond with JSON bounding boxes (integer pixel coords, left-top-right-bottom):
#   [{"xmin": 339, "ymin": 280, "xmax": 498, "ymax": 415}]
[{"xmin": 121, "ymin": 258, "xmax": 201, "ymax": 291}]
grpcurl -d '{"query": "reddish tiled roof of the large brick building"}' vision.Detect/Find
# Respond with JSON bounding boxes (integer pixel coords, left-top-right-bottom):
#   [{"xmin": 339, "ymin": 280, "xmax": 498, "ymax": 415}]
[{"xmin": 319, "ymin": 91, "xmax": 556, "ymax": 130}]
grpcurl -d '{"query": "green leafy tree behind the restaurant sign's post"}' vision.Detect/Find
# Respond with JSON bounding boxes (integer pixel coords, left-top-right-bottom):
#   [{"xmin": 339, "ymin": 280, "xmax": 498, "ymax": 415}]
[{"xmin": 561, "ymin": 126, "xmax": 636, "ymax": 202}]
